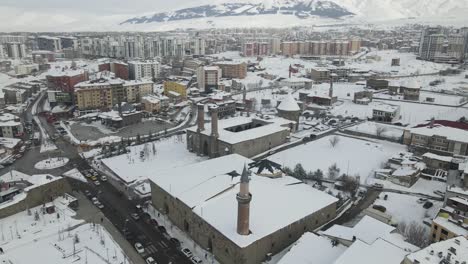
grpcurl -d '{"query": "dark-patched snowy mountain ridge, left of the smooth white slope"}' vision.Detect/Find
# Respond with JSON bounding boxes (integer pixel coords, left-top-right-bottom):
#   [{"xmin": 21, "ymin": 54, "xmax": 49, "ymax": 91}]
[{"xmin": 121, "ymin": 0, "xmax": 352, "ymax": 24}]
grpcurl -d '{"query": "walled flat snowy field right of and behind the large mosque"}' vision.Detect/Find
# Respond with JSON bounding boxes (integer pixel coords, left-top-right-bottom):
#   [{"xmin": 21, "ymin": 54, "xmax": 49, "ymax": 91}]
[{"xmin": 269, "ymin": 136, "xmax": 406, "ymax": 183}]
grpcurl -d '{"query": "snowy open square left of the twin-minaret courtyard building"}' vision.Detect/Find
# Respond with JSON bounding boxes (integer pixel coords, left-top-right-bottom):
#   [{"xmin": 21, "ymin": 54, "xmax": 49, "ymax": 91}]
[{"xmin": 101, "ymin": 136, "xmax": 206, "ymax": 182}]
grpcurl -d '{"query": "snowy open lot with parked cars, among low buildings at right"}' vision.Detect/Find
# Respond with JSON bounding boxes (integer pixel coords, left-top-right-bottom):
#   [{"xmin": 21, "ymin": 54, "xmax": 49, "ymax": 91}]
[{"xmin": 374, "ymin": 192, "xmax": 443, "ymax": 224}]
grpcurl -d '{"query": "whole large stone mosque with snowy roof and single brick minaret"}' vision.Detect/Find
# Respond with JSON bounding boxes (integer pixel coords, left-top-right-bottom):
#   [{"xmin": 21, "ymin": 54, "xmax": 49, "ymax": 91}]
[{"xmin": 150, "ymin": 154, "xmax": 337, "ymax": 264}]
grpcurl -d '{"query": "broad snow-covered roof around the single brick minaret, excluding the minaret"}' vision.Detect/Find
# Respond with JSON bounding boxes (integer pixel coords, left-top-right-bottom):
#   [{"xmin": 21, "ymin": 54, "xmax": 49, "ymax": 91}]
[{"xmin": 149, "ymin": 154, "xmax": 337, "ymax": 247}]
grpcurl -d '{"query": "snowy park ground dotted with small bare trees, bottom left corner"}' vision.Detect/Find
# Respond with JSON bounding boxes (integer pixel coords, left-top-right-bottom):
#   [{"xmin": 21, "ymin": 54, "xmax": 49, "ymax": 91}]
[{"xmin": 0, "ymin": 197, "xmax": 125, "ymax": 264}]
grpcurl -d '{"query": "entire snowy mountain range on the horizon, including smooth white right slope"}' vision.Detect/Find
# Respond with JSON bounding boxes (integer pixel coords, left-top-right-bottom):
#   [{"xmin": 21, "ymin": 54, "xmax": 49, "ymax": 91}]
[{"xmin": 121, "ymin": 0, "xmax": 468, "ymax": 25}]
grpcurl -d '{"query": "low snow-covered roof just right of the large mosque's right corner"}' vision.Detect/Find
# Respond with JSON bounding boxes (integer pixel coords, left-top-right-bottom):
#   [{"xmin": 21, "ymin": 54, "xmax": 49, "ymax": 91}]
[{"xmin": 323, "ymin": 215, "xmax": 395, "ymax": 244}]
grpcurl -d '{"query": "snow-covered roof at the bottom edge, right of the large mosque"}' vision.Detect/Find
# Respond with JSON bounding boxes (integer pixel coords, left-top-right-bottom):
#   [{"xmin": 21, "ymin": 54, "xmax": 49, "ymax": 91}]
[{"xmin": 334, "ymin": 238, "xmax": 408, "ymax": 264}]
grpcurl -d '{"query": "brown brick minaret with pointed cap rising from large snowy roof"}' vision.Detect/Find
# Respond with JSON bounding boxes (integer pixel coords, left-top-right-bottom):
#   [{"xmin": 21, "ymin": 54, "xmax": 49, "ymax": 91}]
[{"xmin": 237, "ymin": 165, "xmax": 252, "ymax": 236}]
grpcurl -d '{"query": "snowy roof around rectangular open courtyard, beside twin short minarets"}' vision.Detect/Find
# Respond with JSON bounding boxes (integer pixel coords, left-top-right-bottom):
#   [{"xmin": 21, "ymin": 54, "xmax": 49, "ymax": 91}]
[{"xmin": 187, "ymin": 116, "xmax": 293, "ymax": 144}]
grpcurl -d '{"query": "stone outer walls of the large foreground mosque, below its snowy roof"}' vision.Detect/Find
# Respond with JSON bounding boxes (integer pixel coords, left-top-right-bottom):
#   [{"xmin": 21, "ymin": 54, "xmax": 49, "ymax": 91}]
[{"xmin": 151, "ymin": 182, "xmax": 336, "ymax": 264}]
